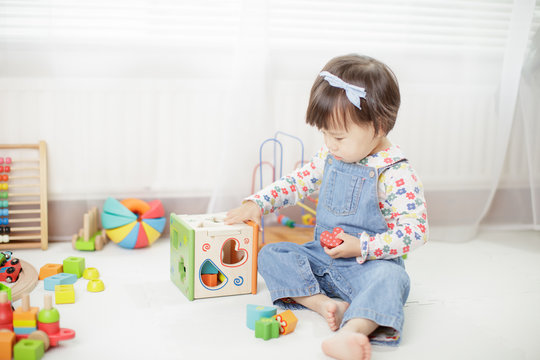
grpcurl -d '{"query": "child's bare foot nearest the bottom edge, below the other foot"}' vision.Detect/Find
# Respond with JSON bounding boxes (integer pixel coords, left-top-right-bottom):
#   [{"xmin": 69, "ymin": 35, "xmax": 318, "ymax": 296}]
[{"xmin": 322, "ymin": 331, "xmax": 371, "ymax": 360}]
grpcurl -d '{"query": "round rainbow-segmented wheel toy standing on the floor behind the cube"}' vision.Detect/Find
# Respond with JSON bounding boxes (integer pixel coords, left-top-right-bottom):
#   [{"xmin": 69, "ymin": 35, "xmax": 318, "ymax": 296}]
[{"xmin": 101, "ymin": 198, "xmax": 165, "ymax": 249}]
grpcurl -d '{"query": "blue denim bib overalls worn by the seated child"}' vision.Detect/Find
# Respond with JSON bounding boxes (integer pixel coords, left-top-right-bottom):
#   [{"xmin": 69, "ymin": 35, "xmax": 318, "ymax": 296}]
[{"xmin": 258, "ymin": 155, "xmax": 409, "ymax": 345}]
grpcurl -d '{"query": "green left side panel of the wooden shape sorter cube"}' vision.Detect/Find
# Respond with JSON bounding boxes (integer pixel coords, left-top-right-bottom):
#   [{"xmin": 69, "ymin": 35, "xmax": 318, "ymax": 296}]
[{"xmin": 170, "ymin": 213, "xmax": 195, "ymax": 301}]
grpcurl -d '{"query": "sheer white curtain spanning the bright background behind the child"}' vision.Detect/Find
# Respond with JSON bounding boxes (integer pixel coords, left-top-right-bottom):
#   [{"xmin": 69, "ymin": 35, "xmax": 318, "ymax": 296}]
[{"xmin": 0, "ymin": 0, "xmax": 540, "ymax": 241}]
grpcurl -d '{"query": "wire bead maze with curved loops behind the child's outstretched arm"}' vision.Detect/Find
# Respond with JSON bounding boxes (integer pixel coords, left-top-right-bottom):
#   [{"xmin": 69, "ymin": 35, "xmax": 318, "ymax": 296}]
[{"xmin": 255, "ymin": 131, "xmax": 317, "ymax": 244}]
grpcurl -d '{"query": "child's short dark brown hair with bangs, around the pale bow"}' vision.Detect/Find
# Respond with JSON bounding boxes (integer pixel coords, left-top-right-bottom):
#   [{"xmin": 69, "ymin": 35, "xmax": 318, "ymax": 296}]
[{"xmin": 306, "ymin": 54, "xmax": 401, "ymax": 135}]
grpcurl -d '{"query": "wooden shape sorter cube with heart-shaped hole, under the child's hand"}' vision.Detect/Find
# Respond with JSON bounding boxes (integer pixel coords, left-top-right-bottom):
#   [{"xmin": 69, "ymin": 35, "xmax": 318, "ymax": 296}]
[{"xmin": 170, "ymin": 213, "xmax": 259, "ymax": 300}]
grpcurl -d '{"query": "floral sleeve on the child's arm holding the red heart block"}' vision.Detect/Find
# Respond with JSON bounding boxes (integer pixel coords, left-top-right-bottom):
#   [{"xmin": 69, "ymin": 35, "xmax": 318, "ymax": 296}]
[{"xmin": 357, "ymin": 162, "xmax": 428, "ymax": 263}]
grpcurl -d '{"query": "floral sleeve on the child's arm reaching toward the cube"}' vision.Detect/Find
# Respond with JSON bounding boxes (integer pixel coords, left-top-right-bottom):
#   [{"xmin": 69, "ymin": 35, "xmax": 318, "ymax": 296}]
[{"xmin": 244, "ymin": 146, "xmax": 328, "ymax": 215}]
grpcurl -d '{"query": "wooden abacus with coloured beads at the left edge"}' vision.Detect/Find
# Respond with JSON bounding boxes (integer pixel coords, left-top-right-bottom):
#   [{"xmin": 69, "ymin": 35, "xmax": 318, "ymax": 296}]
[{"xmin": 0, "ymin": 141, "xmax": 48, "ymax": 250}]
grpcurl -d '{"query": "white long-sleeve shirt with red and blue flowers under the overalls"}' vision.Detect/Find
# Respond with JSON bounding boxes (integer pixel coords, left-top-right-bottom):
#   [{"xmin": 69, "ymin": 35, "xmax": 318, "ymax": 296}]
[{"xmin": 245, "ymin": 145, "xmax": 428, "ymax": 263}]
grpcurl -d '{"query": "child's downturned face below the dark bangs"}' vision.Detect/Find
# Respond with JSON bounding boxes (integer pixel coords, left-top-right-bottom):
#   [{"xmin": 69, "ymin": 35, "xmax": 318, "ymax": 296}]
[{"xmin": 322, "ymin": 123, "xmax": 388, "ymax": 163}]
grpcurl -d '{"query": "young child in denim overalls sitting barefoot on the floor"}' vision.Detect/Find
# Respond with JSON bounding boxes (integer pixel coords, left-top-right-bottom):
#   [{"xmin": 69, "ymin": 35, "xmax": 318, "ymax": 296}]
[{"xmin": 225, "ymin": 55, "xmax": 428, "ymax": 359}]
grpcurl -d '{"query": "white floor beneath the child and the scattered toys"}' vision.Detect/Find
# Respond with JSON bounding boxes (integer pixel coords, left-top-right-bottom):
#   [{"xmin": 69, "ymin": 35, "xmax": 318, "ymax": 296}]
[{"xmin": 8, "ymin": 231, "xmax": 540, "ymax": 360}]
